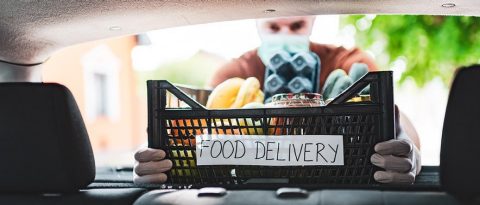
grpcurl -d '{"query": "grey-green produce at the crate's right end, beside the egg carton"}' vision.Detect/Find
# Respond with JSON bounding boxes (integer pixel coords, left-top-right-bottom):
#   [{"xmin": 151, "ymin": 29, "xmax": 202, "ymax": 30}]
[{"xmin": 322, "ymin": 63, "xmax": 370, "ymax": 100}]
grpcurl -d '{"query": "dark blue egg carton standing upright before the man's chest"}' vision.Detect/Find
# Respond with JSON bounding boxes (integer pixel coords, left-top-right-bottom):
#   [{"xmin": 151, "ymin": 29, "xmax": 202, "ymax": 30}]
[{"xmin": 263, "ymin": 50, "xmax": 320, "ymax": 102}]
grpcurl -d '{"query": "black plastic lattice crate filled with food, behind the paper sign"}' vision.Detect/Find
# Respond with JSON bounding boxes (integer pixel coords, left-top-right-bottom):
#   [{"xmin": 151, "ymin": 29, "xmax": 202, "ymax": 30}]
[{"xmin": 147, "ymin": 71, "xmax": 395, "ymax": 188}]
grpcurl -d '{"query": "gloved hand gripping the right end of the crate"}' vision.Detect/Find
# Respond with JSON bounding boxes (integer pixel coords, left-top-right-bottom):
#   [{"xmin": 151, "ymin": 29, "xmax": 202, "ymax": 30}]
[{"xmin": 370, "ymin": 131, "xmax": 421, "ymax": 184}]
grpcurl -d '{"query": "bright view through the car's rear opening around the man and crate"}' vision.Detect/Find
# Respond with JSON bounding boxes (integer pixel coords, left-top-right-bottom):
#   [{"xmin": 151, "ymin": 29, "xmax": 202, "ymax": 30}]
[{"xmin": 43, "ymin": 15, "xmax": 480, "ymax": 166}]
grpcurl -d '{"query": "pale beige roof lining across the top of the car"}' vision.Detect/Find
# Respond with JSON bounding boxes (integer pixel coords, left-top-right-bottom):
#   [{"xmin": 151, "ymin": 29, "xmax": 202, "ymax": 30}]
[{"xmin": 0, "ymin": 0, "xmax": 480, "ymax": 65}]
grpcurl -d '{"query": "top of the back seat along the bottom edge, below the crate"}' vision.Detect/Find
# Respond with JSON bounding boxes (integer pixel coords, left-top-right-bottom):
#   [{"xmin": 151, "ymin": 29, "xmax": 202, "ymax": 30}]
[{"xmin": 134, "ymin": 189, "xmax": 462, "ymax": 205}]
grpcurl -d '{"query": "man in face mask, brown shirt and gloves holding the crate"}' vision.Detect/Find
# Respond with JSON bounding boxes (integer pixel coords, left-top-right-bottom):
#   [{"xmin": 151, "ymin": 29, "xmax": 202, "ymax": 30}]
[{"xmin": 134, "ymin": 16, "xmax": 421, "ymax": 184}]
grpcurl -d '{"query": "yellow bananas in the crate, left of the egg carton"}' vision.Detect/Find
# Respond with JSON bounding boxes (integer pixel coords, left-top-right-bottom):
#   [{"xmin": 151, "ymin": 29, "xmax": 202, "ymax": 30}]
[{"xmin": 206, "ymin": 77, "xmax": 264, "ymax": 109}]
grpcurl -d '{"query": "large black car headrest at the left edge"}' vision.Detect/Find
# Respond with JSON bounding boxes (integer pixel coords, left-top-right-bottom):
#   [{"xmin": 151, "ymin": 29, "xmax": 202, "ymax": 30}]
[{"xmin": 0, "ymin": 83, "xmax": 95, "ymax": 193}]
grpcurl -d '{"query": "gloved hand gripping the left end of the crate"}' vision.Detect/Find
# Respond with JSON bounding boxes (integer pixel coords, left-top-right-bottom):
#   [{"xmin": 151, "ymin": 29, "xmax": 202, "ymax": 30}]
[{"xmin": 133, "ymin": 148, "xmax": 172, "ymax": 184}]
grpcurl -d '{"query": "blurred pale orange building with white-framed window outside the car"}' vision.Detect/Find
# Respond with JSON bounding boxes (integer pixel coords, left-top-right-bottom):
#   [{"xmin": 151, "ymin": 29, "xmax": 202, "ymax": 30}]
[{"xmin": 43, "ymin": 36, "xmax": 147, "ymax": 163}]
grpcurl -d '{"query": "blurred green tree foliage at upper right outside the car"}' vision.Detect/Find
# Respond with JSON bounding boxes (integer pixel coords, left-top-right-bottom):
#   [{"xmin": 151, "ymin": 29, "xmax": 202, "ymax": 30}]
[{"xmin": 341, "ymin": 15, "xmax": 480, "ymax": 86}]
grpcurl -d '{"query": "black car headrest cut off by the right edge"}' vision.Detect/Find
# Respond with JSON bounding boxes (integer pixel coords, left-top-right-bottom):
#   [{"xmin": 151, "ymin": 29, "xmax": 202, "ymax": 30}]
[{"xmin": 440, "ymin": 65, "xmax": 480, "ymax": 196}]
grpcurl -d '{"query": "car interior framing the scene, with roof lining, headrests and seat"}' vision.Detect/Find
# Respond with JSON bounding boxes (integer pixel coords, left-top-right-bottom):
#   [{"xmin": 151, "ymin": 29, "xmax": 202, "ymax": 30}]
[{"xmin": 0, "ymin": 0, "xmax": 480, "ymax": 205}]
